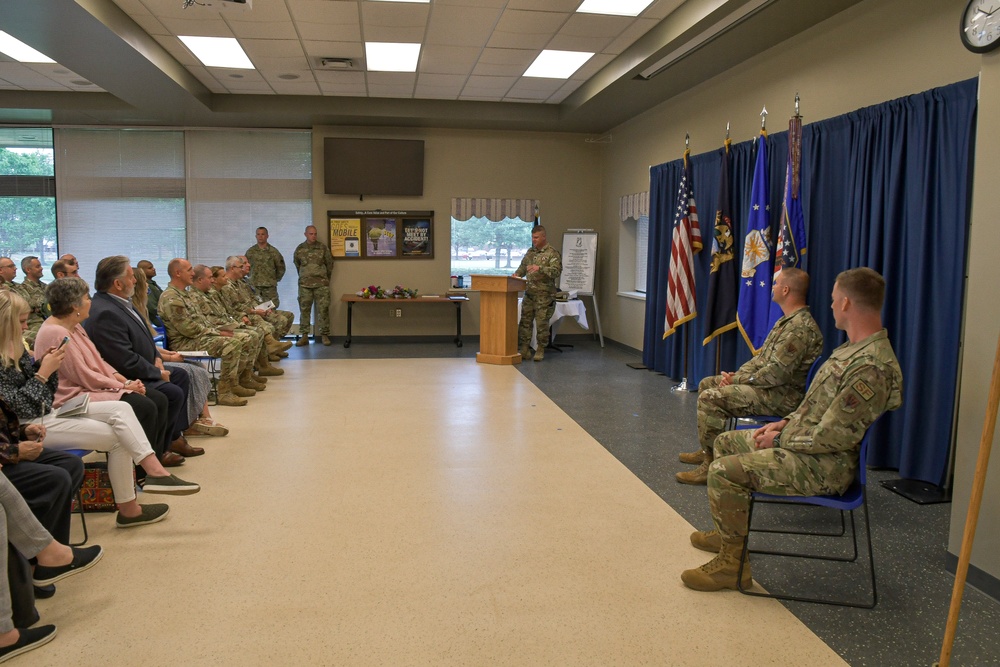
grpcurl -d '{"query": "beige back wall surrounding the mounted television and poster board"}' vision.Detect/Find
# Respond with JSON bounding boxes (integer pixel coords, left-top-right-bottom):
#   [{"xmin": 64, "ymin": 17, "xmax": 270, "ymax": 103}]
[{"xmin": 313, "ymin": 127, "xmax": 601, "ymax": 336}]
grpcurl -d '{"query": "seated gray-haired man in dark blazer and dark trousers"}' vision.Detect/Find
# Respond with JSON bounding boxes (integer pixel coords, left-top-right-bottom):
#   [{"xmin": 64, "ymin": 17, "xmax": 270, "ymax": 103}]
[{"xmin": 83, "ymin": 255, "xmax": 199, "ymax": 466}]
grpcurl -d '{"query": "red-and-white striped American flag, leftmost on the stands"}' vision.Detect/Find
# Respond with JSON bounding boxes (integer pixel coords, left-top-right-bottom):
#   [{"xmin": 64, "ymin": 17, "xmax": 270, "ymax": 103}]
[{"xmin": 663, "ymin": 150, "xmax": 701, "ymax": 338}]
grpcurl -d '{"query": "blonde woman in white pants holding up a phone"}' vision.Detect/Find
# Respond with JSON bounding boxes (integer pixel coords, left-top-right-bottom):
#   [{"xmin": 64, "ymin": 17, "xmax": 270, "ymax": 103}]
[{"xmin": 0, "ymin": 290, "xmax": 200, "ymax": 528}]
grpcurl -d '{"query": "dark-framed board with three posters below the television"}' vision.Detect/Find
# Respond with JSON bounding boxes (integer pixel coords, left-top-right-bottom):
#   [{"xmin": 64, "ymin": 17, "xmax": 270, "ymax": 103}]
[{"xmin": 327, "ymin": 211, "xmax": 434, "ymax": 259}]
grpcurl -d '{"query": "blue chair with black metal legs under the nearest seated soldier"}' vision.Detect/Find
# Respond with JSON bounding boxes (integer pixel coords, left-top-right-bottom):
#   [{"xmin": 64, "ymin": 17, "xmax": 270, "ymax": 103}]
[{"xmin": 736, "ymin": 420, "xmax": 878, "ymax": 609}]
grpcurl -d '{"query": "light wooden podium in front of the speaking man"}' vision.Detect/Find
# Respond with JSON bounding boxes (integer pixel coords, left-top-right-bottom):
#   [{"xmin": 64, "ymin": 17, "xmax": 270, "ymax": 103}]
[{"xmin": 472, "ymin": 275, "xmax": 527, "ymax": 366}]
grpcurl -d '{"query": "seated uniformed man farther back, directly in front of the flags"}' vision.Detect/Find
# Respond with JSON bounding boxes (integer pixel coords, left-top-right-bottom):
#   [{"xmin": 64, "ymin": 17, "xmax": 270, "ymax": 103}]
[{"xmin": 677, "ymin": 268, "xmax": 823, "ymax": 484}]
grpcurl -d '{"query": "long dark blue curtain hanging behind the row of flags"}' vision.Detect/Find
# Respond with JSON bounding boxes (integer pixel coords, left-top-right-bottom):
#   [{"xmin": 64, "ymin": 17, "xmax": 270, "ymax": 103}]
[{"xmin": 643, "ymin": 79, "xmax": 978, "ymax": 486}]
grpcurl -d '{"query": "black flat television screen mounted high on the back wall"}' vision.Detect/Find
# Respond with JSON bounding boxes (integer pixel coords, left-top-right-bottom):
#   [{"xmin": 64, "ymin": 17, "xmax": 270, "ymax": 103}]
[{"xmin": 323, "ymin": 138, "xmax": 424, "ymax": 196}]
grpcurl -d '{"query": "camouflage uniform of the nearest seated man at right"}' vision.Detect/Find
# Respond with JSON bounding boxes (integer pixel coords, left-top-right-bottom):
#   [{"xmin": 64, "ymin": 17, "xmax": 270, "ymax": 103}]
[{"xmin": 708, "ymin": 329, "xmax": 903, "ymax": 543}]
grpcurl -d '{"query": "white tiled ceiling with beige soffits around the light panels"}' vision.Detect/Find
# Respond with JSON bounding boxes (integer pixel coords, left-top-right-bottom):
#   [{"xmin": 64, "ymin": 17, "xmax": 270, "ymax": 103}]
[{"xmin": 0, "ymin": 0, "xmax": 859, "ymax": 132}]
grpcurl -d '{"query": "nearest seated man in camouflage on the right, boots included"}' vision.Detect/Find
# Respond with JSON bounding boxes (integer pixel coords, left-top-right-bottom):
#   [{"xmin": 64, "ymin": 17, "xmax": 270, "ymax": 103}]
[{"xmin": 681, "ymin": 267, "xmax": 903, "ymax": 591}]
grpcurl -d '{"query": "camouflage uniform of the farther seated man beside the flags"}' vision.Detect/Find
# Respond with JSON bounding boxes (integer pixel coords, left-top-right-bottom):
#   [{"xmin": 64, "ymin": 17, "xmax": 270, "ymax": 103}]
[{"xmin": 698, "ymin": 308, "xmax": 823, "ymax": 460}]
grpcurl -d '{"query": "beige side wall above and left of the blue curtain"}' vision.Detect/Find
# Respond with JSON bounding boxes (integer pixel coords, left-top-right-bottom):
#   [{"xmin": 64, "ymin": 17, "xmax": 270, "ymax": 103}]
[{"xmin": 600, "ymin": 0, "xmax": 979, "ymax": 349}]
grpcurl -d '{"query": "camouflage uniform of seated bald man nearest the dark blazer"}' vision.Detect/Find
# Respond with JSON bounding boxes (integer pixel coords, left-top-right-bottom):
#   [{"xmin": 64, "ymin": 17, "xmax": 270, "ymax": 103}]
[{"xmin": 159, "ymin": 285, "xmax": 250, "ymax": 385}]
